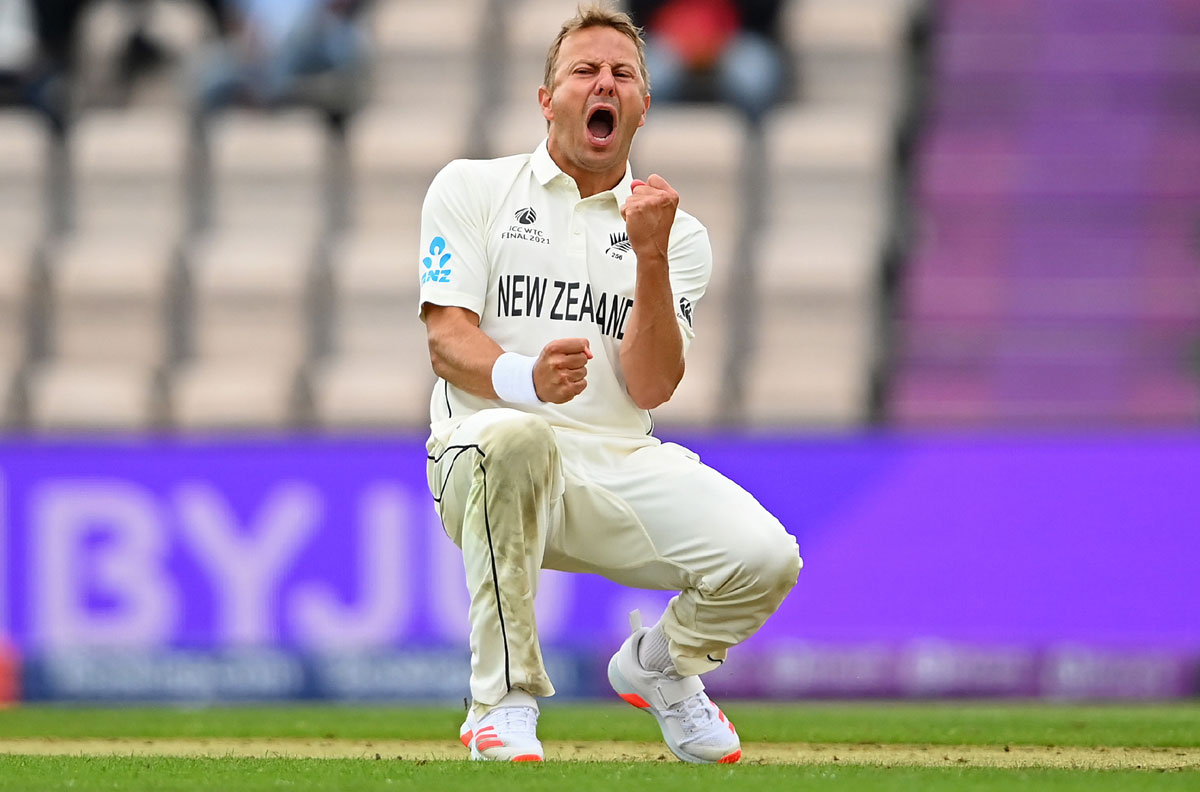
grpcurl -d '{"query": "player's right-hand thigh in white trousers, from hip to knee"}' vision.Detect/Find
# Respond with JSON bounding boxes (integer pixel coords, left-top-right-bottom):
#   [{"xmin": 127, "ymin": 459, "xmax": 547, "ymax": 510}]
[{"xmin": 546, "ymin": 444, "xmax": 791, "ymax": 590}]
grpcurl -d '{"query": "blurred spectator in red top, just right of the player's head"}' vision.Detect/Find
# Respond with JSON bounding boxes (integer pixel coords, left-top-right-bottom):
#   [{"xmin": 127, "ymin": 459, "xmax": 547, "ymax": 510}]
[{"xmin": 628, "ymin": 0, "xmax": 786, "ymax": 122}]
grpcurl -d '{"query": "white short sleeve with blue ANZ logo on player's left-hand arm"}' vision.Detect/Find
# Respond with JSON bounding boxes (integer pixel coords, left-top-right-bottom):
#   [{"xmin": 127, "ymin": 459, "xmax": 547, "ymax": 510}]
[{"xmin": 416, "ymin": 160, "xmax": 488, "ymax": 318}]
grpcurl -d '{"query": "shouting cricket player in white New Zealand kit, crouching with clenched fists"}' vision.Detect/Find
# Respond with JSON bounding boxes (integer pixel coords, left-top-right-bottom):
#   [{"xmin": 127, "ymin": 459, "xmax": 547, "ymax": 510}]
[{"xmin": 418, "ymin": 6, "xmax": 800, "ymax": 762}]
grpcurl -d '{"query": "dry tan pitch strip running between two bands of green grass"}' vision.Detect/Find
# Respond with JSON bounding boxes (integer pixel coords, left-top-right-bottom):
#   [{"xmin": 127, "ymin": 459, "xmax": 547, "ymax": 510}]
[{"xmin": 0, "ymin": 738, "xmax": 1200, "ymax": 770}]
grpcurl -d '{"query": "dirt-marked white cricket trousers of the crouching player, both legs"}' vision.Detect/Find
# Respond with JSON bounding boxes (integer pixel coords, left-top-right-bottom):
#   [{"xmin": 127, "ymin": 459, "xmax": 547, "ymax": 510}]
[{"xmin": 428, "ymin": 408, "xmax": 800, "ymax": 704}]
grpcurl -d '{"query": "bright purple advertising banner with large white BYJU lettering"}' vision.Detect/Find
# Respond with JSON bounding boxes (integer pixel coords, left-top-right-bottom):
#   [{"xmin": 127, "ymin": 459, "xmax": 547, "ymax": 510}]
[{"xmin": 0, "ymin": 434, "xmax": 1200, "ymax": 692}]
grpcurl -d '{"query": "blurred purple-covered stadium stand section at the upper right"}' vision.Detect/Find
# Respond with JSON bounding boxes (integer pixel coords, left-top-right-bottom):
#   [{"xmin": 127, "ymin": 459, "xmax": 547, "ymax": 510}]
[{"xmin": 888, "ymin": 0, "xmax": 1200, "ymax": 426}]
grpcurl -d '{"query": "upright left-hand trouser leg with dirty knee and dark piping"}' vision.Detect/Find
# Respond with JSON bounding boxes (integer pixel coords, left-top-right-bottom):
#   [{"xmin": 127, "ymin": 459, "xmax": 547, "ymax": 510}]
[{"xmin": 430, "ymin": 409, "xmax": 563, "ymax": 704}]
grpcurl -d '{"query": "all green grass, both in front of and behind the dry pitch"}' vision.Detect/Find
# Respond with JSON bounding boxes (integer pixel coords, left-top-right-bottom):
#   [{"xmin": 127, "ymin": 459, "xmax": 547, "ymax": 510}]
[{"xmin": 0, "ymin": 701, "xmax": 1200, "ymax": 792}]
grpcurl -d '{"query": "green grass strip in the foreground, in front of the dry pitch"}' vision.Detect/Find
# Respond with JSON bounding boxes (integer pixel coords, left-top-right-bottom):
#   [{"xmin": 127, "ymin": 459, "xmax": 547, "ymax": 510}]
[{"xmin": 0, "ymin": 757, "xmax": 1198, "ymax": 792}]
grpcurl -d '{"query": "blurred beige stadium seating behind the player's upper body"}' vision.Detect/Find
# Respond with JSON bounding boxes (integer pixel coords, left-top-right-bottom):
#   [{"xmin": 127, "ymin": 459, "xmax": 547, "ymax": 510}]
[{"xmin": 0, "ymin": 0, "xmax": 925, "ymax": 431}]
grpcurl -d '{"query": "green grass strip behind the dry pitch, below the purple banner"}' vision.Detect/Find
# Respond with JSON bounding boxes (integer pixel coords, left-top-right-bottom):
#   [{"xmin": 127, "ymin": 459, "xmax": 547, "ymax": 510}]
[{"xmin": 0, "ymin": 701, "xmax": 1200, "ymax": 748}]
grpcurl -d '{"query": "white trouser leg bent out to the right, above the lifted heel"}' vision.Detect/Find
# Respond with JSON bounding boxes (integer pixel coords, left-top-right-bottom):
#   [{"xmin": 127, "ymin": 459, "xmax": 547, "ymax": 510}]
[{"xmin": 550, "ymin": 445, "xmax": 800, "ymax": 676}]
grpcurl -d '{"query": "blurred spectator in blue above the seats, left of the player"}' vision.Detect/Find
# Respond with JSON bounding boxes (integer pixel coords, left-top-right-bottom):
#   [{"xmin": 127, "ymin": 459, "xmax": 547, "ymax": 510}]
[{"xmin": 194, "ymin": 0, "xmax": 366, "ymax": 118}]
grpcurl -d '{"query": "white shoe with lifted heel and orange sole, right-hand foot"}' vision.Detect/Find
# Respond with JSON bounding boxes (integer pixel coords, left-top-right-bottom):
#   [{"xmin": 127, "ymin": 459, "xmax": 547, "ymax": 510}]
[{"xmin": 608, "ymin": 612, "xmax": 742, "ymax": 764}]
